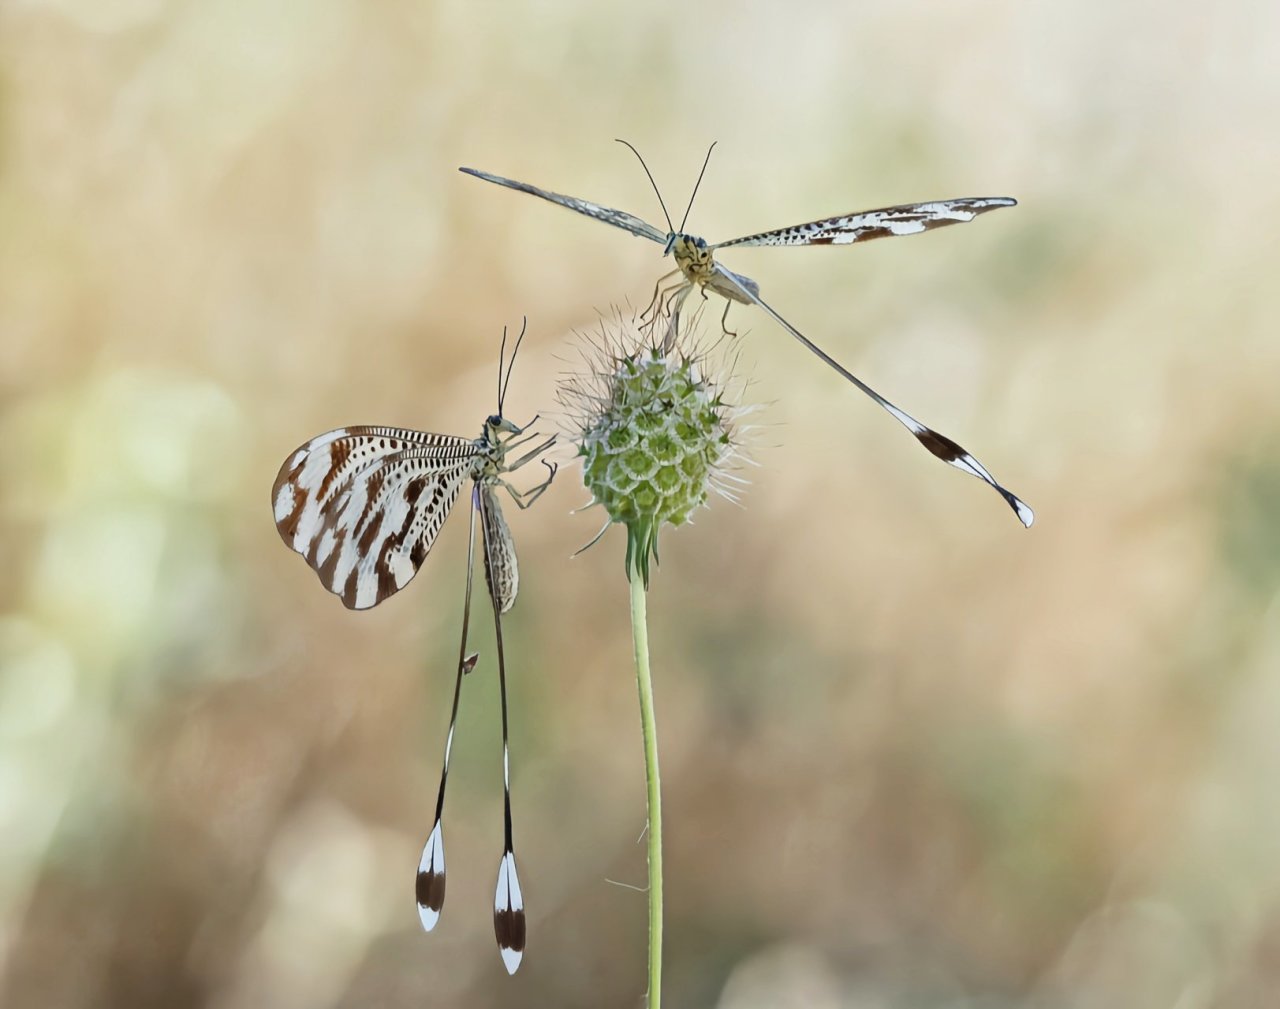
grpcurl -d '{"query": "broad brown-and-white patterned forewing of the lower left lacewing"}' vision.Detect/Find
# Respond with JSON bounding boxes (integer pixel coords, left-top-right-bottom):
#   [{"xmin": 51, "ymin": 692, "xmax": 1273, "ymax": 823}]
[{"xmin": 271, "ymin": 428, "xmax": 475, "ymax": 609}]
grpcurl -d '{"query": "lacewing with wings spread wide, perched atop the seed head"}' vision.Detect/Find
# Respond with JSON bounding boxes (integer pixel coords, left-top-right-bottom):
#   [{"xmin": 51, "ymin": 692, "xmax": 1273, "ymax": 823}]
[{"xmin": 458, "ymin": 147, "xmax": 1036, "ymax": 528}]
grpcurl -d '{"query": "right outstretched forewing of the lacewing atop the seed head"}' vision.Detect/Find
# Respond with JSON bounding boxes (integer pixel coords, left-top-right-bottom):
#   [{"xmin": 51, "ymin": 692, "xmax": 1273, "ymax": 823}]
[{"xmin": 712, "ymin": 196, "xmax": 1018, "ymax": 248}]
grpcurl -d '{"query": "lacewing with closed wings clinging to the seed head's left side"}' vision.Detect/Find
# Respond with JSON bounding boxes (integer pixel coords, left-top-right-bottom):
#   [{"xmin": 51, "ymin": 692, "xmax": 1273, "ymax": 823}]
[{"xmin": 271, "ymin": 327, "xmax": 556, "ymax": 973}]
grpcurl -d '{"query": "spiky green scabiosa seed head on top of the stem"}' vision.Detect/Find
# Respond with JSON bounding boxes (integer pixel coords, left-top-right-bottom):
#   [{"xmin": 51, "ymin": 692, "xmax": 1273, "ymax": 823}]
[{"xmin": 559, "ymin": 315, "xmax": 746, "ymax": 586}]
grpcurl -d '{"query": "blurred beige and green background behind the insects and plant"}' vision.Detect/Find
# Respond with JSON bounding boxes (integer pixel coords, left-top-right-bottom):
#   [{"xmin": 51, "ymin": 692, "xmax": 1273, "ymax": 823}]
[{"xmin": 0, "ymin": 0, "xmax": 1280, "ymax": 1009}]
